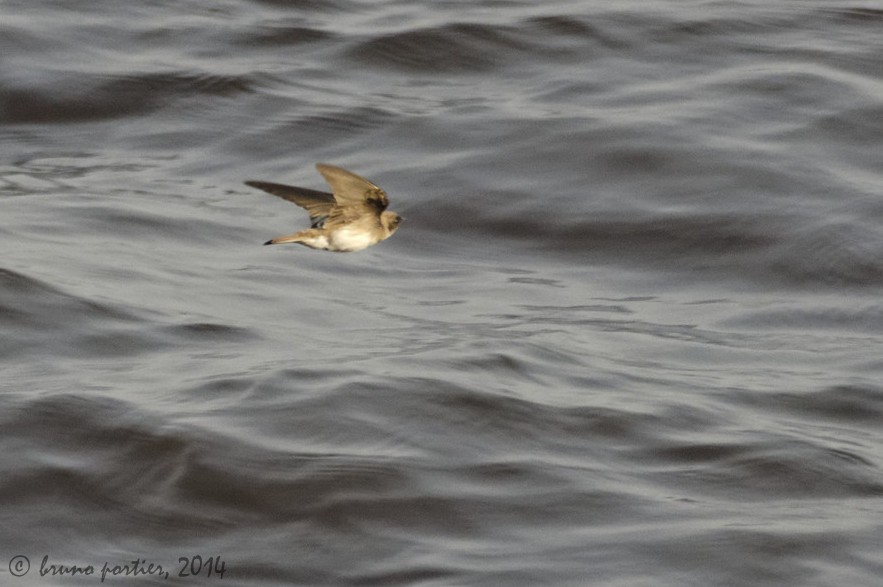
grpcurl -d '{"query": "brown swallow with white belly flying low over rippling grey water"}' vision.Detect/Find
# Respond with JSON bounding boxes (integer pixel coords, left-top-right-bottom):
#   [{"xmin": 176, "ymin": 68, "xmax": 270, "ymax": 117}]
[{"xmin": 245, "ymin": 163, "xmax": 402, "ymax": 253}]
